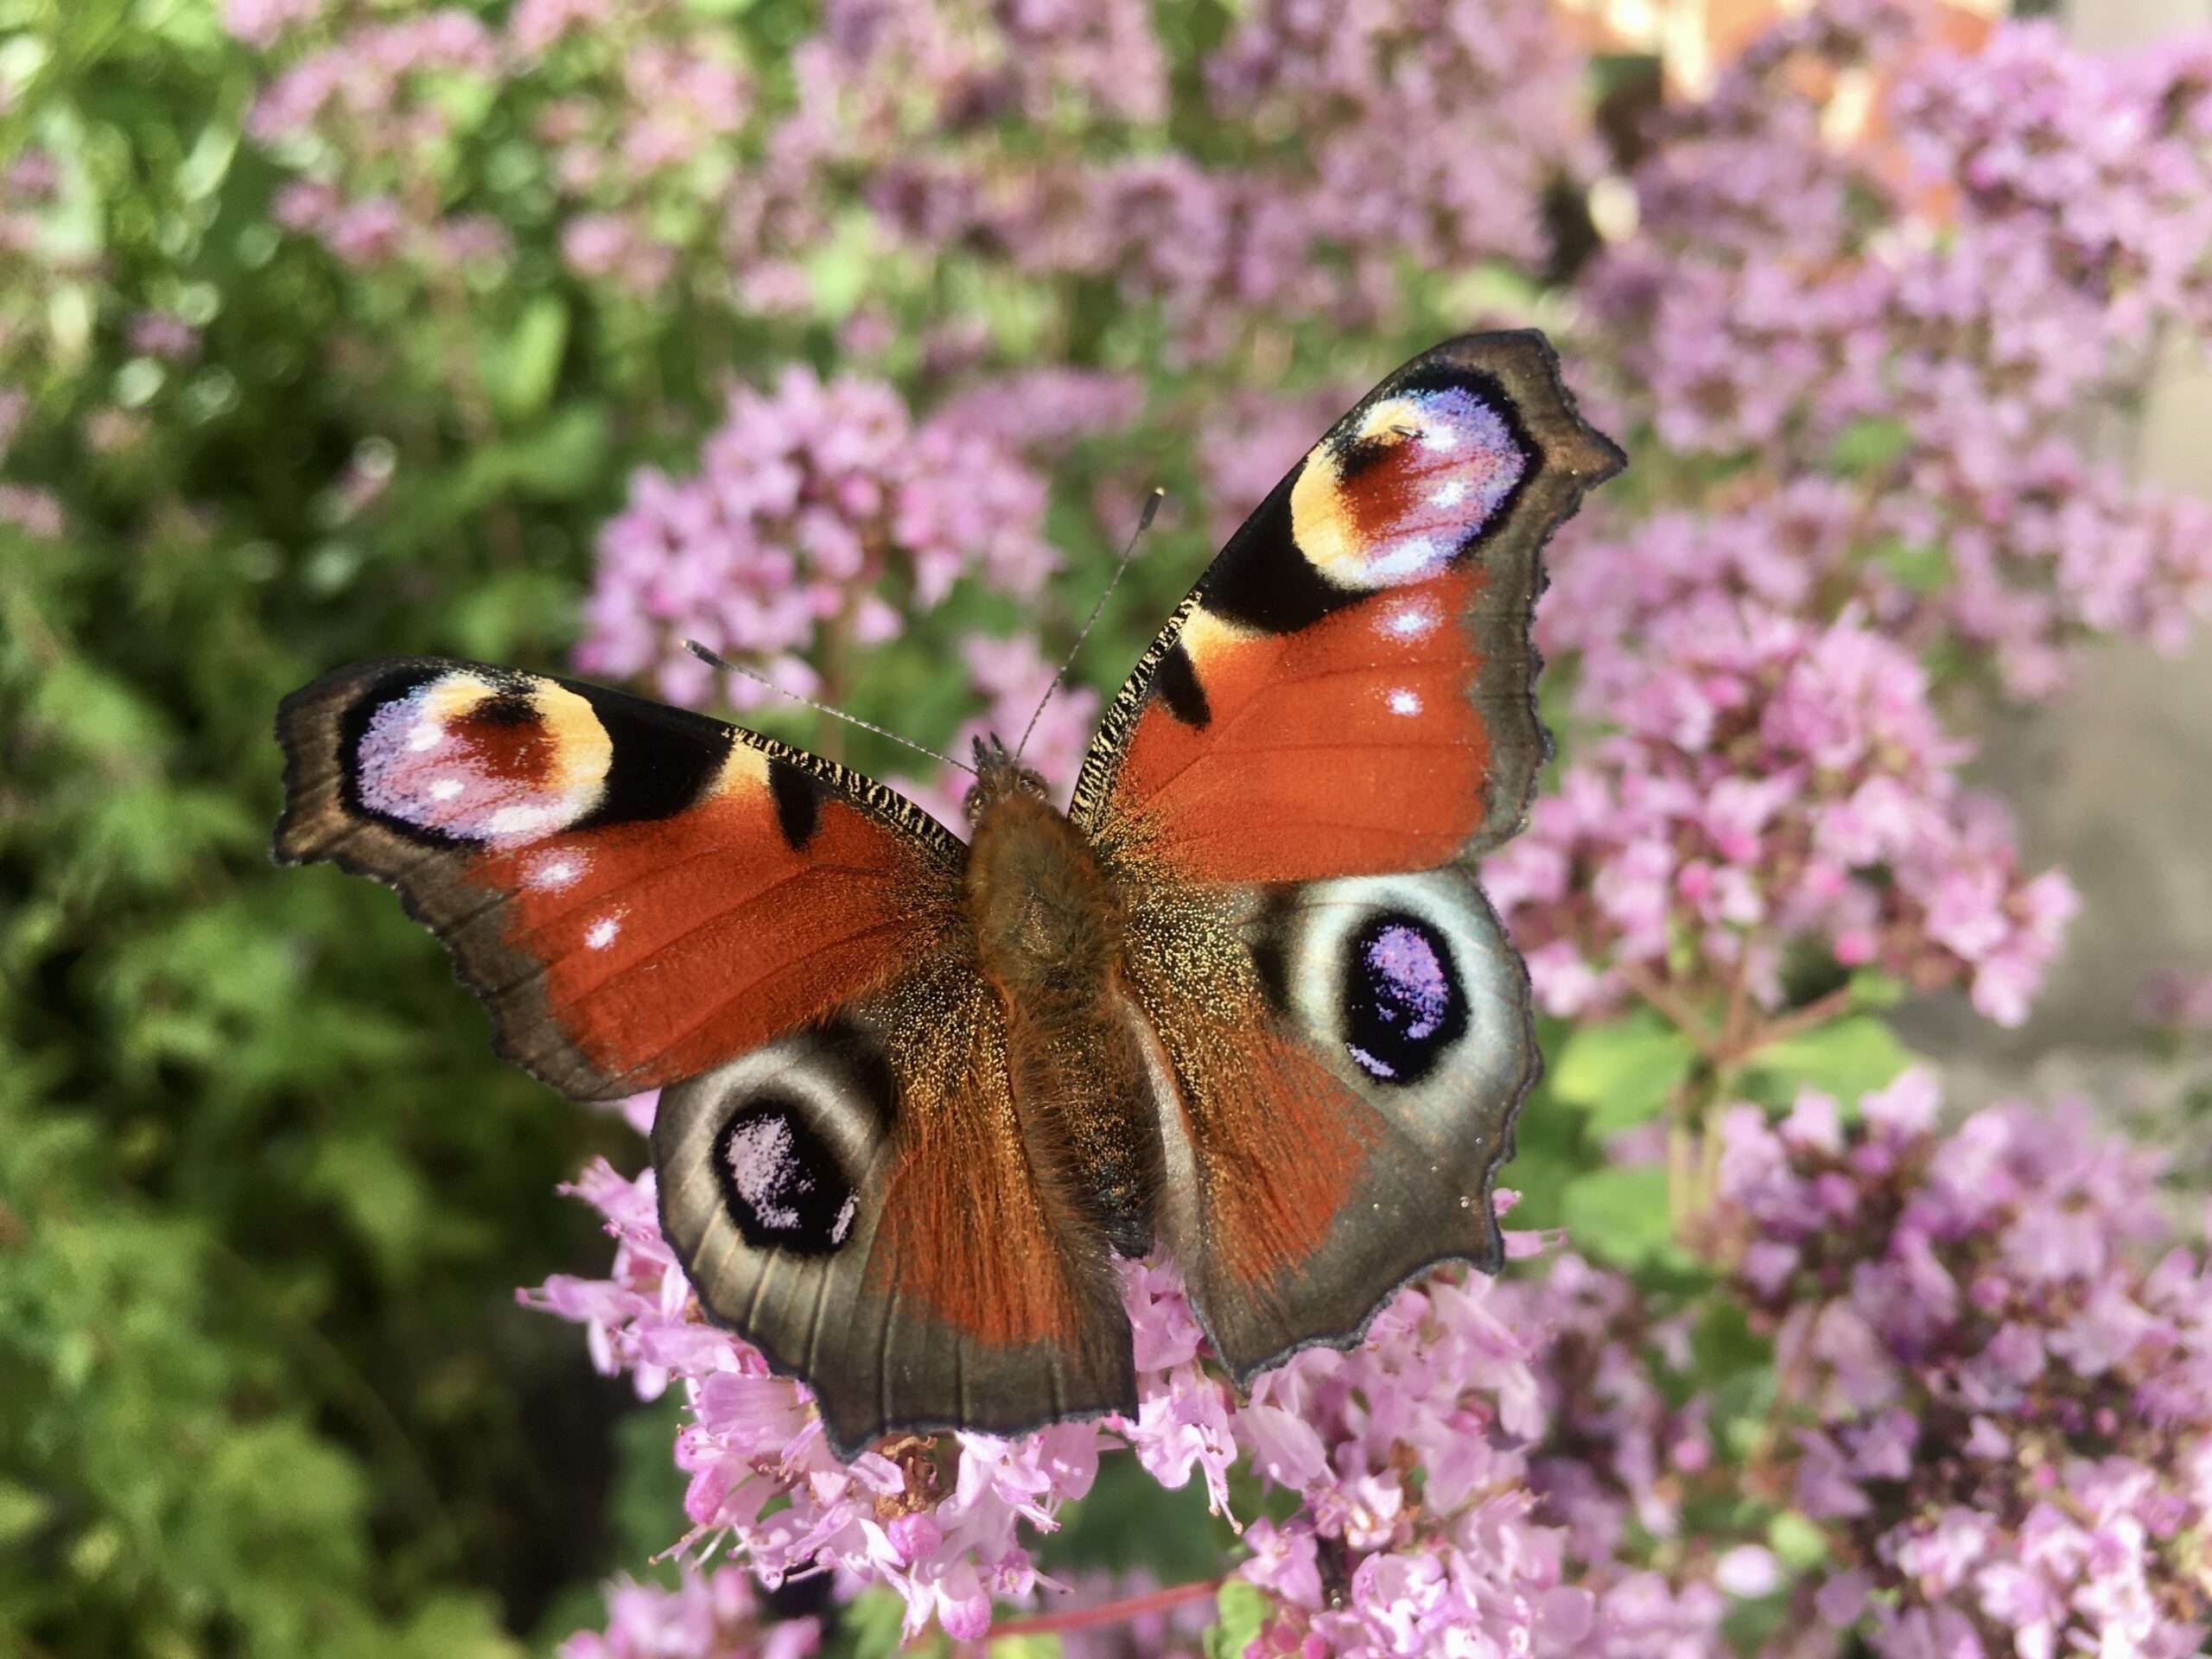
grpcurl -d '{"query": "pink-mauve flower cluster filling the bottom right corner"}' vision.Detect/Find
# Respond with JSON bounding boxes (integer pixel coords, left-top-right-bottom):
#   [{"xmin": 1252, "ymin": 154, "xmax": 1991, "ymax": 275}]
[{"xmin": 1710, "ymin": 1073, "xmax": 2212, "ymax": 1659}]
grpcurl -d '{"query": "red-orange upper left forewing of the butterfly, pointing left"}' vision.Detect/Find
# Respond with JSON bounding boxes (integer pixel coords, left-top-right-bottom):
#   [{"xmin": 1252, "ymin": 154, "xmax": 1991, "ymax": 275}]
[{"xmin": 276, "ymin": 659, "xmax": 963, "ymax": 1099}]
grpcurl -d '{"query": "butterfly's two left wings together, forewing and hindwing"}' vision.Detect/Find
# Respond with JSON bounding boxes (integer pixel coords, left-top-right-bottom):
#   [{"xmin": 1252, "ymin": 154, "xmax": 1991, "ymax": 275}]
[{"xmin": 276, "ymin": 661, "xmax": 1137, "ymax": 1458}]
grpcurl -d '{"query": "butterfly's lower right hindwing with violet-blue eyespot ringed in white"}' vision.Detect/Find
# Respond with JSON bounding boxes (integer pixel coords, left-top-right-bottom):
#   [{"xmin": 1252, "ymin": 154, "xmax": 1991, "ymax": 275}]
[{"xmin": 1128, "ymin": 865, "xmax": 1537, "ymax": 1385}]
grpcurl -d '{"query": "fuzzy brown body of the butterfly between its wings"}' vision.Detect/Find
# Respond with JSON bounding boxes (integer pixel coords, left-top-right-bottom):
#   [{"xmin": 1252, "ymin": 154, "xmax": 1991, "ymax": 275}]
[{"xmin": 967, "ymin": 791, "xmax": 1164, "ymax": 1256}]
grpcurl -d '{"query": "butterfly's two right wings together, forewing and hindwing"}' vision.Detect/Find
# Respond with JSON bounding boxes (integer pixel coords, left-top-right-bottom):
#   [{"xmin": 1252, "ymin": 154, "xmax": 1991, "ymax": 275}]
[{"xmin": 1073, "ymin": 334, "xmax": 1621, "ymax": 1380}]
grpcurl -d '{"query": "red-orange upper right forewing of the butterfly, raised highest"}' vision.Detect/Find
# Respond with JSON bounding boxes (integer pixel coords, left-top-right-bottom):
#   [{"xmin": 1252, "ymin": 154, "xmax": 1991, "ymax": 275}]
[{"xmin": 1073, "ymin": 334, "xmax": 1621, "ymax": 882}]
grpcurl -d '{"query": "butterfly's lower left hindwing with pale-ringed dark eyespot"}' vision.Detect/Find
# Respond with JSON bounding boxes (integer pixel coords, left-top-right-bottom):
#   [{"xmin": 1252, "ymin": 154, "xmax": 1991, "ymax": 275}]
[{"xmin": 652, "ymin": 955, "xmax": 1137, "ymax": 1458}]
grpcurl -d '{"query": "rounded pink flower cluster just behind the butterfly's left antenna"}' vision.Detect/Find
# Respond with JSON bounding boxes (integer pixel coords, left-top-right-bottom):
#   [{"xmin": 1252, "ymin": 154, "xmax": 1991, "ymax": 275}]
[{"xmin": 577, "ymin": 370, "xmax": 1058, "ymax": 719}]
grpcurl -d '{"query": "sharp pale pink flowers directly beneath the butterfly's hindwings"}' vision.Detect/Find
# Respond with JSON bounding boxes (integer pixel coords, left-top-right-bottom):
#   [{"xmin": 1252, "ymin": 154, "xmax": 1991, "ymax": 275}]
[{"xmin": 524, "ymin": 1164, "xmax": 1778, "ymax": 1659}]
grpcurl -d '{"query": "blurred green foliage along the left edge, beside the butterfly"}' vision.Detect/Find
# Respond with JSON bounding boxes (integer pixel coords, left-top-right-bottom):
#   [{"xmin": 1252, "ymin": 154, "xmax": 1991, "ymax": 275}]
[{"xmin": 0, "ymin": 4, "xmax": 650, "ymax": 1659}]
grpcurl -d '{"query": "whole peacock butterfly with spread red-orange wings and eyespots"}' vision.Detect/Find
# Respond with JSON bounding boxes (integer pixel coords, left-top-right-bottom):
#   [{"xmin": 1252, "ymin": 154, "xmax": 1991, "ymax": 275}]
[{"xmin": 274, "ymin": 332, "xmax": 1624, "ymax": 1460}]
